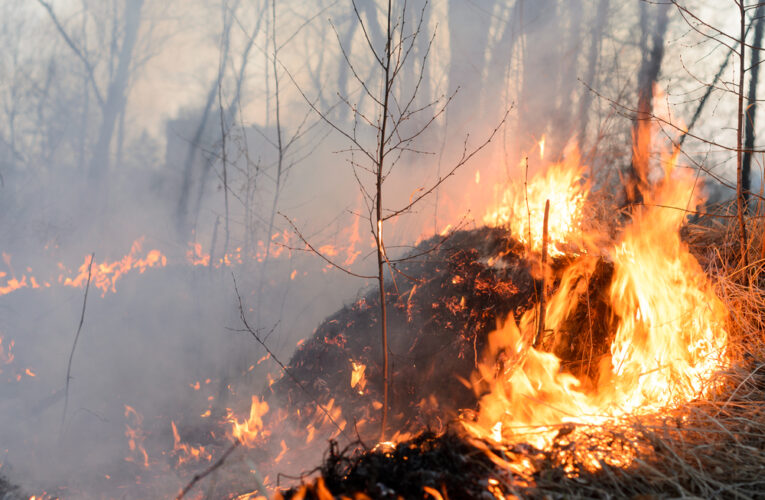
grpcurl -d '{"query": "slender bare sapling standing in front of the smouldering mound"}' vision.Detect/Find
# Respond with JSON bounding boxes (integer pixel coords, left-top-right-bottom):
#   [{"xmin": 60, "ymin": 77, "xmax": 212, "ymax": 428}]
[{"xmin": 288, "ymin": 0, "xmax": 507, "ymax": 441}]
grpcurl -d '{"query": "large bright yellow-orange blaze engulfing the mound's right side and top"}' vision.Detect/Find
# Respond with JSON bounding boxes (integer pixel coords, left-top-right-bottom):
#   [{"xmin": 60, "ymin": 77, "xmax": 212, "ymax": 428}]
[{"xmin": 463, "ymin": 137, "xmax": 727, "ymax": 475}]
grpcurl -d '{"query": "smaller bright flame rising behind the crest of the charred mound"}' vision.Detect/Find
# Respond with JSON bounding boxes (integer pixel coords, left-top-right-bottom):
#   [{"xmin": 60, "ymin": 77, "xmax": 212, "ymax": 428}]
[{"xmin": 483, "ymin": 149, "xmax": 589, "ymax": 257}]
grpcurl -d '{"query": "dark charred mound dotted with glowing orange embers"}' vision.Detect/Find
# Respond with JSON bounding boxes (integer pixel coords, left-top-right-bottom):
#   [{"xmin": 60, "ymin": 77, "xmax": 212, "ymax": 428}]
[{"xmin": 262, "ymin": 228, "xmax": 612, "ymax": 440}]
